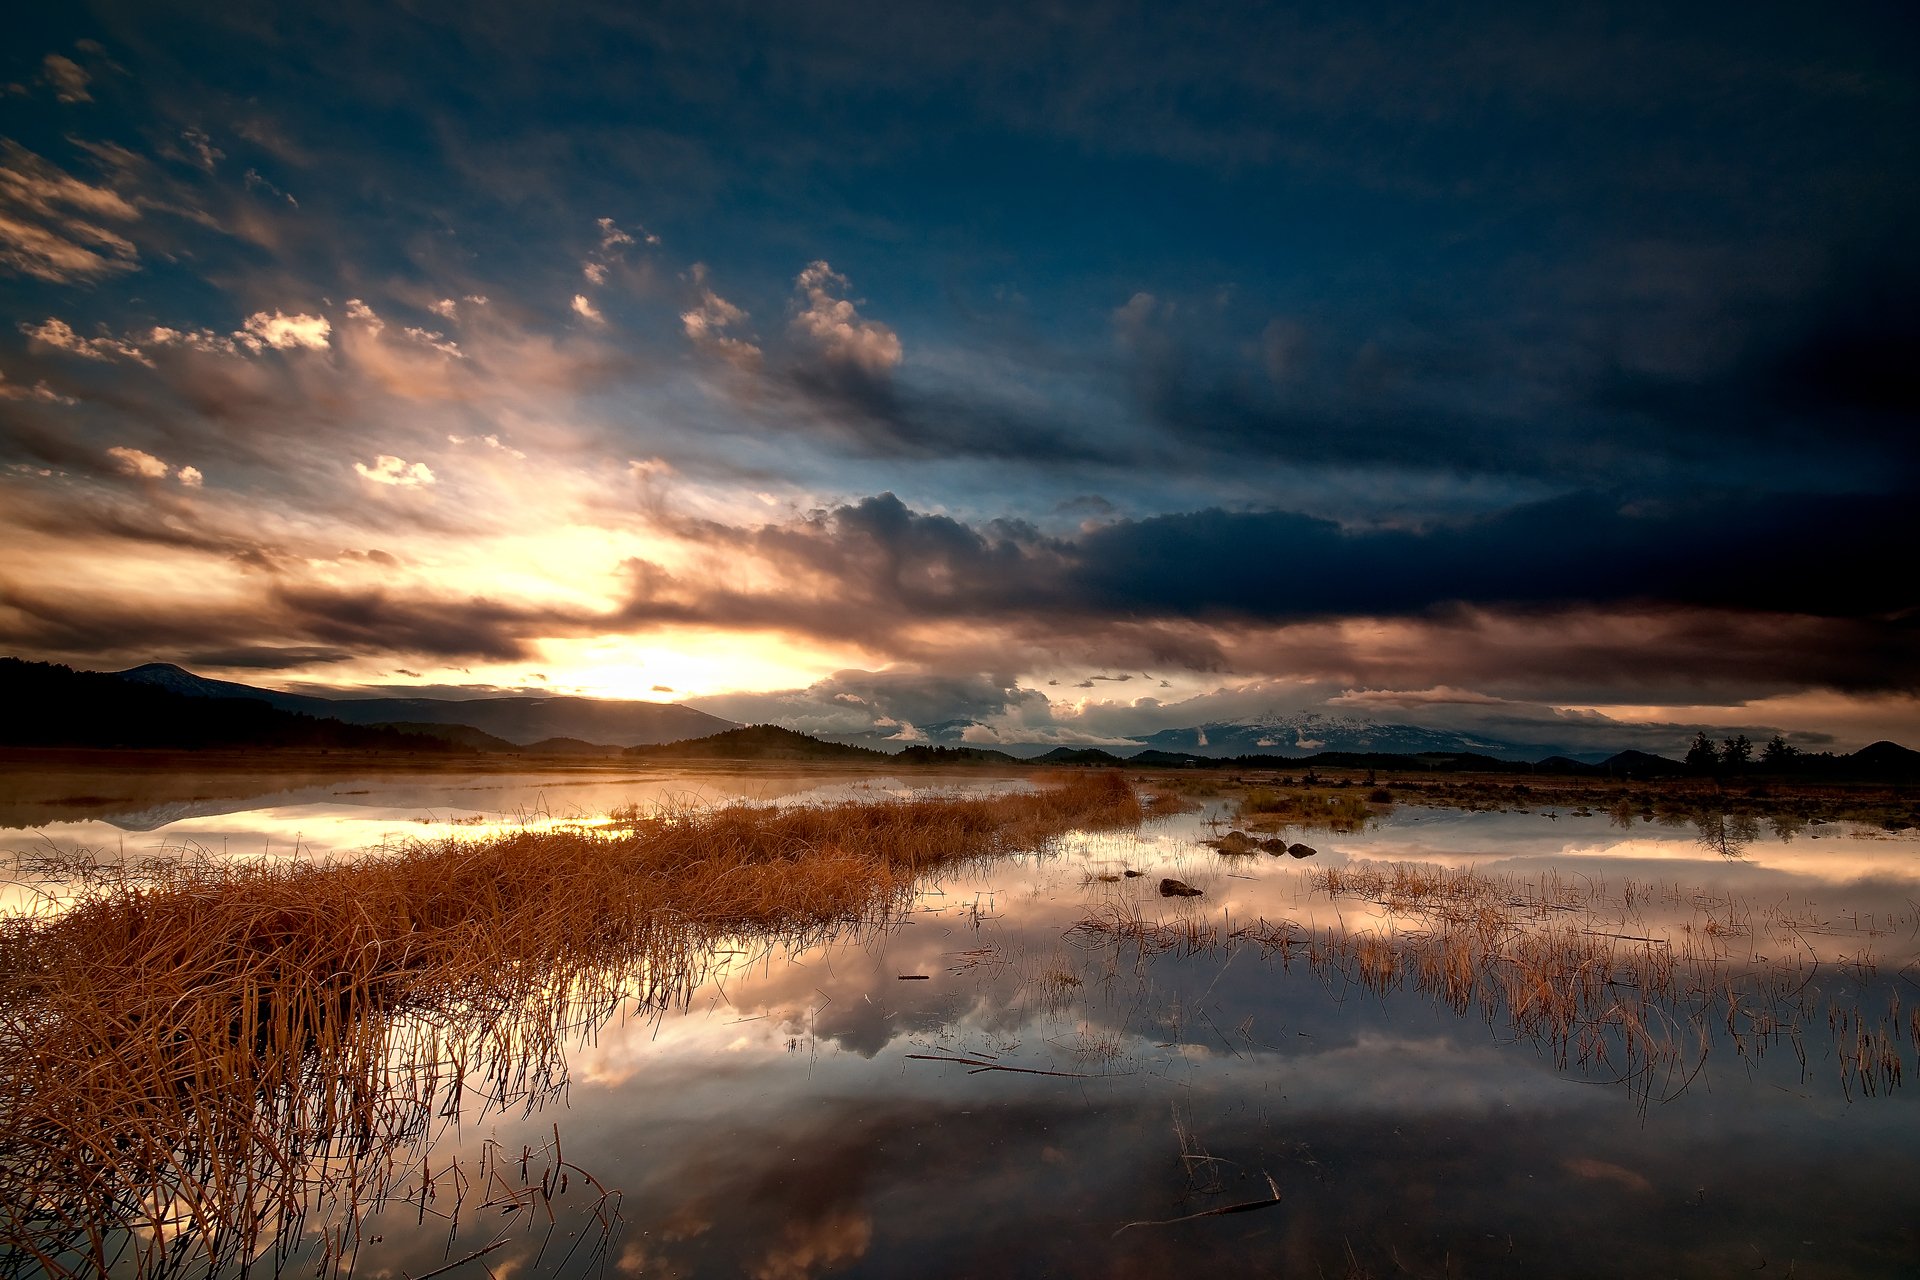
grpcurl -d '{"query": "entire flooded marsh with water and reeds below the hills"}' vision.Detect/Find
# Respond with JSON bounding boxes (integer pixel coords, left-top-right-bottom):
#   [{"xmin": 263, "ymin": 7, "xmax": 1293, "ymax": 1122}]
[{"xmin": 0, "ymin": 764, "xmax": 1920, "ymax": 1276}]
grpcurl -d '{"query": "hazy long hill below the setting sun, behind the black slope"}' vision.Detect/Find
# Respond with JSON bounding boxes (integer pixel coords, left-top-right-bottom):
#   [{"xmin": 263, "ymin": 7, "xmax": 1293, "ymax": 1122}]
[{"xmin": 117, "ymin": 662, "xmax": 735, "ymax": 747}]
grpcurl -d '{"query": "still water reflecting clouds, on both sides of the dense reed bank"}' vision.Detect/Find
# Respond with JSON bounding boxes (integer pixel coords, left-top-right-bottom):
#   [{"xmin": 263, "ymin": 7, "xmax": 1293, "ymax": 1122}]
[{"xmin": 0, "ymin": 770, "xmax": 1920, "ymax": 1278}]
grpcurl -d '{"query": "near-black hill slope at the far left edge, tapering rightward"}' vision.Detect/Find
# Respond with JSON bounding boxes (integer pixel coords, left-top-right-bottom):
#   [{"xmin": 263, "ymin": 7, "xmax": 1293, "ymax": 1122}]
[{"xmin": 0, "ymin": 658, "xmax": 463, "ymax": 752}]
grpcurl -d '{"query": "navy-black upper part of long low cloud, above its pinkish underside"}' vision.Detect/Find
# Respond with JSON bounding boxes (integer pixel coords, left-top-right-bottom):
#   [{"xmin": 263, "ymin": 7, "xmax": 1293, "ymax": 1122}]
[{"xmin": 628, "ymin": 493, "xmax": 1920, "ymax": 633}]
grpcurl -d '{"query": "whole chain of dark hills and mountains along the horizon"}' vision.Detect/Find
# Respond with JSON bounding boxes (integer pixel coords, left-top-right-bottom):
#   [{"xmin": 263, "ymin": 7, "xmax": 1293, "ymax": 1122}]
[{"xmin": 0, "ymin": 658, "xmax": 1920, "ymax": 777}]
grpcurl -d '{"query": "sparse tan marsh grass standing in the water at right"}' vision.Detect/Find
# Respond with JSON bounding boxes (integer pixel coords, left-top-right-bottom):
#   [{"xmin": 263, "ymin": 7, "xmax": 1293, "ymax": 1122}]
[{"xmin": 1073, "ymin": 862, "xmax": 1920, "ymax": 1107}]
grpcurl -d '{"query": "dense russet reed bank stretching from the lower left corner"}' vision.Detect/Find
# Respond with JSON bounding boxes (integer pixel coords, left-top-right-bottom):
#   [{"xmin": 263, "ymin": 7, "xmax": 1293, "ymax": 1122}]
[{"xmin": 0, "ymin": 773, "xmax": 1142, "ymax": 1274}]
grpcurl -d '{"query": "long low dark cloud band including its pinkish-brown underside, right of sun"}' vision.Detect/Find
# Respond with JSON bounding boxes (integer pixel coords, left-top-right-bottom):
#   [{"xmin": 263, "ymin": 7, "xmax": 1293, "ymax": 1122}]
[{"xmin": 620, "ymin": 493, "xmax": 1920, "ymax": 690}]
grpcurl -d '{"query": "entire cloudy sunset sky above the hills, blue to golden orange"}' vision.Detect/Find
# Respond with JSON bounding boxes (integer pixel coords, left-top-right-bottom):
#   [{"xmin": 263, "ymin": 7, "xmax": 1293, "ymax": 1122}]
[{"xmin": 0, "ymin": 0, "xmax": 1920, "ymax": 750}]
